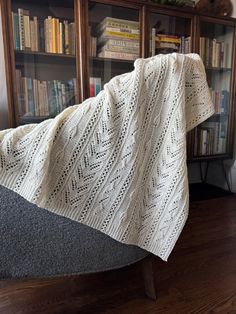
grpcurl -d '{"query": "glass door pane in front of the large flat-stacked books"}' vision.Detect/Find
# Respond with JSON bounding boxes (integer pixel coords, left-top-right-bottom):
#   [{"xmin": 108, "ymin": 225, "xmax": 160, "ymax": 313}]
[{"xmin": 89, "ymin": 2, "xmax": 140, "ymax": 97}]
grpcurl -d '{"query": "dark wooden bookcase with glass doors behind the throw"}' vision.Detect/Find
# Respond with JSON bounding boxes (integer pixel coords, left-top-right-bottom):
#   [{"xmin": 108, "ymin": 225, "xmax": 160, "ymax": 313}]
[{"xmin": 0, "ymin": 0, "xmax": 236, "ymax": 161}]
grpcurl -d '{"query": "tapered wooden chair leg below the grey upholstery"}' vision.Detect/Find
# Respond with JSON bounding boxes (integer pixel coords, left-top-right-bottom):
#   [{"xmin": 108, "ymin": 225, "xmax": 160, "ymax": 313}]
[{"xmin": 142, "ymin": 255, "xmax": 157, "ymax": 300}]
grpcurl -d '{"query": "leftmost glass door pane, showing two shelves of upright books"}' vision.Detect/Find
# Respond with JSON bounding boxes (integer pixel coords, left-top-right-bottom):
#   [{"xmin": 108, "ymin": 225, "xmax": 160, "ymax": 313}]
[{"xmin": 12, "ymin": 0, "xmax": 78, "ymax": 124}]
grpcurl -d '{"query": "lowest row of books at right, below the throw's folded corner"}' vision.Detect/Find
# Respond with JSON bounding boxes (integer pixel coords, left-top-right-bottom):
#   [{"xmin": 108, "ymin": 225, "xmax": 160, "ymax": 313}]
[{"xmin": 194, "ymin": 120, "xmax": 227, "ymax": 156}]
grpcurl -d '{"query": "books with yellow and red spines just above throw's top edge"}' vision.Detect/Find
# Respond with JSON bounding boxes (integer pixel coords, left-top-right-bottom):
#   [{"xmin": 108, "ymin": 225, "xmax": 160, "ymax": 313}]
[{"xmin": 150, "ymin": 28, "xmax": 191, "ymax": 56}]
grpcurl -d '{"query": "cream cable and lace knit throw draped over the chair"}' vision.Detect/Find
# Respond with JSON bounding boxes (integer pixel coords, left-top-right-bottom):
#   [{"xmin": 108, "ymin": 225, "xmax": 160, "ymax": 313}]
[{"xmin": 0, "ymin": 53, "xmax": 214, "ymax": 260}]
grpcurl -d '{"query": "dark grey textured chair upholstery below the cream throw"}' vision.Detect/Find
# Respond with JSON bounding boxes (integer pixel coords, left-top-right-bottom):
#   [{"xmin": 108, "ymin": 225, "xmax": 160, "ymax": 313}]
[{"xmin": 0, "ymin": 186, "xmax": 149, "ymax": 280}]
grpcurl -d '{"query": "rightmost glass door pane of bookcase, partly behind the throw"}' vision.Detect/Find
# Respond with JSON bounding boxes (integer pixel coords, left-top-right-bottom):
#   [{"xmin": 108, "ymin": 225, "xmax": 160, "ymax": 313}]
[{"xmin": 194, "ymin": 23, "xmax": 234, "ymax": 156}]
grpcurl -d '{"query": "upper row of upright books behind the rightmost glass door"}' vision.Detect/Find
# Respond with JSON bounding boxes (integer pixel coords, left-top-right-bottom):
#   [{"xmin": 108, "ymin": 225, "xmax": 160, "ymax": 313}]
[{"xmin": 200, "ymin": 37, "xmax": 229, "ymax": 68}]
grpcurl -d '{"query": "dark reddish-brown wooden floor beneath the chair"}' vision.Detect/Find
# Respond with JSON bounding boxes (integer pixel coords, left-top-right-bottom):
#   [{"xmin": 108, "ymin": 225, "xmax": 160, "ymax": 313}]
[{"xmin": 0, "ymin": 196, "xmax": 236, "ymax": 314}]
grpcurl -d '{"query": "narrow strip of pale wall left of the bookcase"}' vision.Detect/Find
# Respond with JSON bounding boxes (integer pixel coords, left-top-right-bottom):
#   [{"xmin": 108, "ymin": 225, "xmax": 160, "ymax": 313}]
[{"xmin": 0, "ymin": 3, "xmax": 8, "ymax": 130}]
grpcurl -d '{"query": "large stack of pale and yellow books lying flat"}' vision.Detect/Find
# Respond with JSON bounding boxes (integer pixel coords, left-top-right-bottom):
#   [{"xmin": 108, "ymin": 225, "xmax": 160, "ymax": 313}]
[{"xmin": 97, "ymin": 17, "xmax": 140, "ymax": 60}]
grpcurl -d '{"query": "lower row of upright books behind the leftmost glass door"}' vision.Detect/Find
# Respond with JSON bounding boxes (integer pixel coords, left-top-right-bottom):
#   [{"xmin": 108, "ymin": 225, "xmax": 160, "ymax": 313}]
[{"xmin": 16, "ymin": 69, "xmax": 77, "ymax": 117}]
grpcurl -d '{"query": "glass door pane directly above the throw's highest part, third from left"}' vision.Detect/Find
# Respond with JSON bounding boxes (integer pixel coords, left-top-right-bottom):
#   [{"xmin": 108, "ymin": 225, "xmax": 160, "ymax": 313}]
[{"xmin": 149, "ymin": 13, "xmax": 191, "ymax": 56}]
